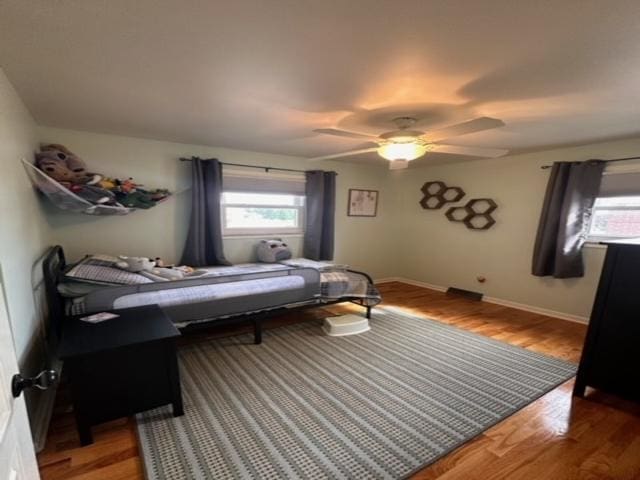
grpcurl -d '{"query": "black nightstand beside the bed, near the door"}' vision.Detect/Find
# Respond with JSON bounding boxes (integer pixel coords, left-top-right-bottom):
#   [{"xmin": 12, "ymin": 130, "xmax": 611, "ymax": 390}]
[{"xmin": 58, "ymin": 305, "xmax": 183, "ymax": 445}]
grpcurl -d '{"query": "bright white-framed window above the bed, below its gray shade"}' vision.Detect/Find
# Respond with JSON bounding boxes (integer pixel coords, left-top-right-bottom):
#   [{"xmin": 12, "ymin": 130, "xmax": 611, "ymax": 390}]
[{"xmin": 221, "ymin": 192, "xmax": 304, "ymax": 235}]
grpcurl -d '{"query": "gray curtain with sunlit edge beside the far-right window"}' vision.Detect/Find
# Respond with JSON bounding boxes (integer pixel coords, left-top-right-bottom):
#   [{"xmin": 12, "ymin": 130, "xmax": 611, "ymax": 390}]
[{"xmin": 532, "ymin": 160, "xmax": 606, "ymax": 278}]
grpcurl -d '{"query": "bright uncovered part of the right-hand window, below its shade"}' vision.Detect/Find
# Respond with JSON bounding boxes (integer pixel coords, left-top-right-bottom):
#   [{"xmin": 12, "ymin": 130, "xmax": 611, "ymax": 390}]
[{"xmin": 588, "ymin": 195, "xmax": 640, "ymax": 241}]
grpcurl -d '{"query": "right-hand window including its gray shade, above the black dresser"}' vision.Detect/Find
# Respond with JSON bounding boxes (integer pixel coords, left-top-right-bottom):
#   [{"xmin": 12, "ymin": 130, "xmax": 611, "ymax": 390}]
[{"xmin": 588, "ymin": 162, "xmax": 640, "ymax": 241}]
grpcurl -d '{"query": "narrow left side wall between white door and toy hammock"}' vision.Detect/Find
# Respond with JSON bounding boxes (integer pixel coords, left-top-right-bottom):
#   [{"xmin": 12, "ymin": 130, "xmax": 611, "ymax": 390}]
[{"xmin": 0, "ymin": 70, "xmax": 49, "ymax": 358}]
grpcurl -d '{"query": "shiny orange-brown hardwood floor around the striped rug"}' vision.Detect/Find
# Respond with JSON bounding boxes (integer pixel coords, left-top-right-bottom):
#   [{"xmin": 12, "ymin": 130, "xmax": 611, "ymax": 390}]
[{"xmin": 38, "ymin": 282, "xmax": 640, "ymax": 480}]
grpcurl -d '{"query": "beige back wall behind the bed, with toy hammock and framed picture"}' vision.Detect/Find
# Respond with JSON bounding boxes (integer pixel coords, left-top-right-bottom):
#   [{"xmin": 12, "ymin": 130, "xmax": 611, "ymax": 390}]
[{"xmin": 39, "ymin": 127, "xmax": 397, "ymax": 278}]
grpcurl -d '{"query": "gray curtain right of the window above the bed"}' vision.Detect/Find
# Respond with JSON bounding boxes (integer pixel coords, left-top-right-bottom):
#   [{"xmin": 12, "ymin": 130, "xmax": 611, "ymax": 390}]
[{"xmin": 303, "ymin": 170, "xmax": 337, "ymax": 260}]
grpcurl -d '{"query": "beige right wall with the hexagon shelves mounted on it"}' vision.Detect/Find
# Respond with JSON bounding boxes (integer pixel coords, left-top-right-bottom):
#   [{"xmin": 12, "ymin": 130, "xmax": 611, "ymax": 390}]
[{"xmin": 393, "ymin": 139, "xmax": 640, "ymax": 320}]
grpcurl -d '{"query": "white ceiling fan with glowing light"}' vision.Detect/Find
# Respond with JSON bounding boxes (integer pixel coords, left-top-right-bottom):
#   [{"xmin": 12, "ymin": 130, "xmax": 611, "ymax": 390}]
[{"xmin": 310, "ymin": 117, "xmax": 509, "ymax": 170}]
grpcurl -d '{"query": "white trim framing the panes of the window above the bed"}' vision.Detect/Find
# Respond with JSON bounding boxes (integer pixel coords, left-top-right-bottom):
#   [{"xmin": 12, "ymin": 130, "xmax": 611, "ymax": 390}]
[{"xmin": 220, "ymin": 190, "xmax": 306, "ymax": 238}]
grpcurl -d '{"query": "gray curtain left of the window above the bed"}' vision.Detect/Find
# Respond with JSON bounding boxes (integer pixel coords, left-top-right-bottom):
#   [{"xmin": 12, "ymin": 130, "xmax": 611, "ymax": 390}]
[{"xmin": 180, "ymin": 157, "xmax": 231, "ymax": 267}]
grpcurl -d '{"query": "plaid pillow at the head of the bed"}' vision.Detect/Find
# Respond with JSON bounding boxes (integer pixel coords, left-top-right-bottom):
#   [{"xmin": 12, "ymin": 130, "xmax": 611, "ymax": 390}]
[{"xmin": 64, "ymin": 255, "xmax": 153, "ymax": 285}]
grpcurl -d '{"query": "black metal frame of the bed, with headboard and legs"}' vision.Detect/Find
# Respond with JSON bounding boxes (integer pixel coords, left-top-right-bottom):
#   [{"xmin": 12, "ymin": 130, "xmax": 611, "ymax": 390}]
[{"xmin": 42, "ymin": 245, "xmax": 373, "ymax": 345}]
